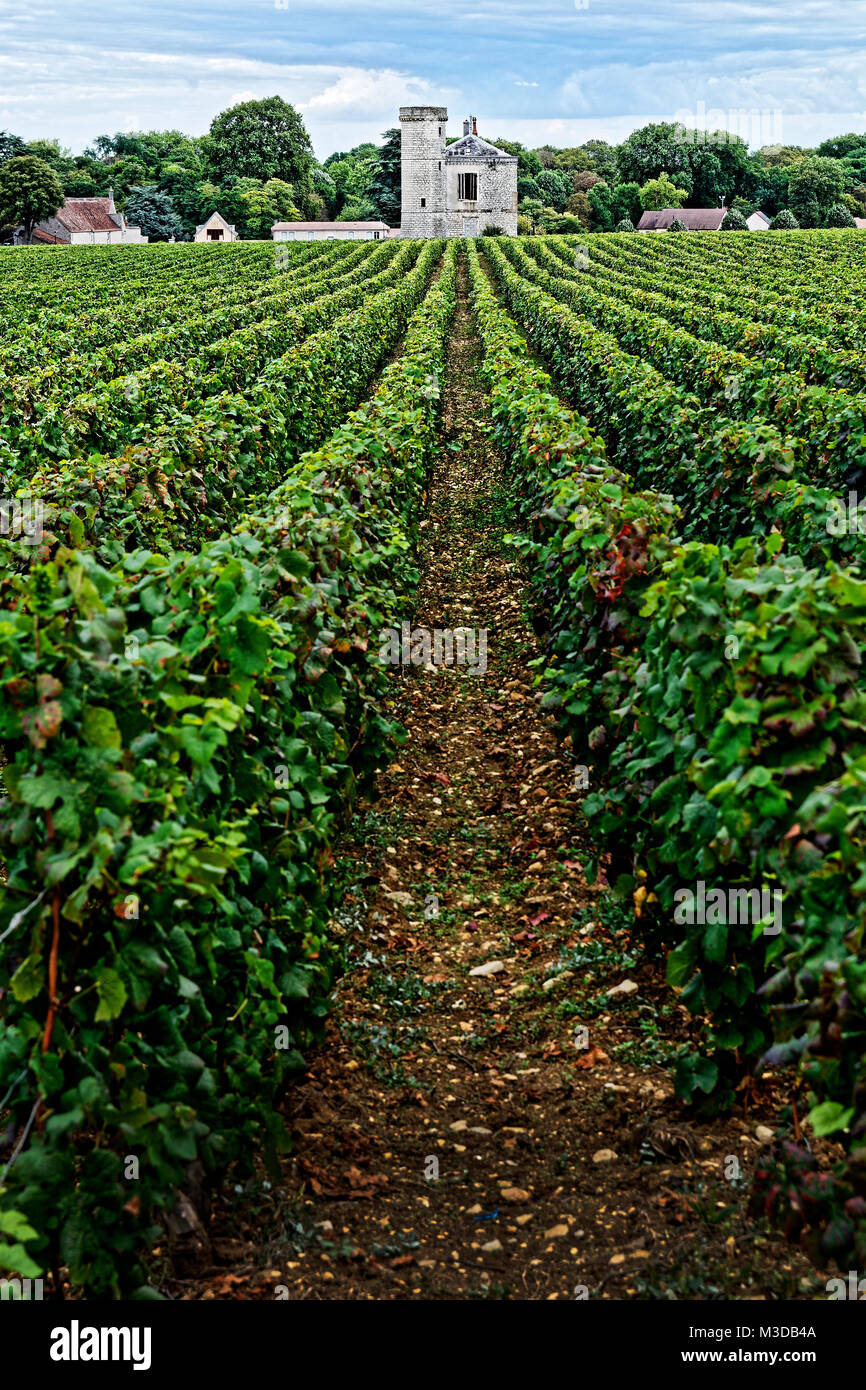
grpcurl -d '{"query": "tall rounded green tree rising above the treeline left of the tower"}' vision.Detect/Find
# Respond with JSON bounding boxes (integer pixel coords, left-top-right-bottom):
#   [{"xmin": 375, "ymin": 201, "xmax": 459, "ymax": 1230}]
[{"xmin": 206, "ymin": 96, "xmax": 313, "ymax": 204}]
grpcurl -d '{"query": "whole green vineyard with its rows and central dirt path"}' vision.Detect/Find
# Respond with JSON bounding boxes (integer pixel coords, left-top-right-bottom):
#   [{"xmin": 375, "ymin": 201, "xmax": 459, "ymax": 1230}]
[{"xmin": 0, "ymin": 231, "xmax": 866, "ymax": 1298}]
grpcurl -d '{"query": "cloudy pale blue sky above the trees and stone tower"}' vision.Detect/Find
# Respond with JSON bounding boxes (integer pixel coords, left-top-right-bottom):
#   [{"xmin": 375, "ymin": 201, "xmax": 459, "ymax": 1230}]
[{"xmin": 0, "ymin": 0, "xmax": 866, "ymax": 158}]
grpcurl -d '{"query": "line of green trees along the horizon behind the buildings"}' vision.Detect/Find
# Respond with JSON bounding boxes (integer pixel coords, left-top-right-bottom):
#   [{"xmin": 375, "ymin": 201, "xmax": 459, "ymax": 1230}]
[{"xmin": 0, "ymin": 96, "xmax": 866, "ymax": 240}]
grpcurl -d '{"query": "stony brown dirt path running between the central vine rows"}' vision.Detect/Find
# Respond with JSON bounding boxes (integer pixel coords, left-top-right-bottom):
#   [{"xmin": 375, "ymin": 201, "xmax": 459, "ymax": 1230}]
[{"xmin": 168, "ymin": 250, "xmax": 816, "ymax": 1300}]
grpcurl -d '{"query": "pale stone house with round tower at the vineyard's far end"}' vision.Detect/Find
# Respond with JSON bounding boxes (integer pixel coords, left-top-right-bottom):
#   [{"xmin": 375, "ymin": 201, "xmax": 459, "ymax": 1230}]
[{"xmin": 400, "ymin": 106, "xmax": 517, "ymax": 236}]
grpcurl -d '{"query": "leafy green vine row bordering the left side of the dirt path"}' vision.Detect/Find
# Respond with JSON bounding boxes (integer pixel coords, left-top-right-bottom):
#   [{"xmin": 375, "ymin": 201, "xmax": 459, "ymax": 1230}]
[{"xmin": 0, "ymin": 242, "xmax": 455, "ymax": 1295}]
